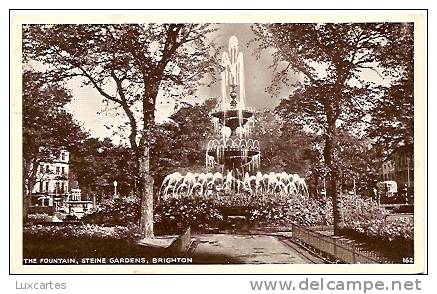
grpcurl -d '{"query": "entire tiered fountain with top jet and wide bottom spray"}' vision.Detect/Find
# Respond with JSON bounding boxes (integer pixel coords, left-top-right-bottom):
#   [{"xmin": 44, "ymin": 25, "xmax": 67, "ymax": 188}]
[{"xmin": 160, "ymin": 36, "xmax": 308, "ymax": 200}]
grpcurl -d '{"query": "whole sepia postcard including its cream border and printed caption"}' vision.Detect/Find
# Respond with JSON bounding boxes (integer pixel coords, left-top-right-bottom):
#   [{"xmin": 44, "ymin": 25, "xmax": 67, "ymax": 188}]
[{"xmin": 9, "ymin": 10, "xmax": 427, "ymax": 274}]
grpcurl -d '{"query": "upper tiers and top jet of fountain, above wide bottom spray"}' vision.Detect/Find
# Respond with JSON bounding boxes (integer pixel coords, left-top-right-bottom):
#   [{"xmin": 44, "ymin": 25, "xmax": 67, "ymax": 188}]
[{"xmin": 206, "ymin": 36, "xmax": 260, "ymax": 179}]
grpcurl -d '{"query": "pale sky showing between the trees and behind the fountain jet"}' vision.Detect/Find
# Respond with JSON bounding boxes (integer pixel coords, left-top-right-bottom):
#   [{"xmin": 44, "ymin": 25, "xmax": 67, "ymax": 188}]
[{"xmin": 63, "ymin": 24, "xmax": 287, "ymax": 142}]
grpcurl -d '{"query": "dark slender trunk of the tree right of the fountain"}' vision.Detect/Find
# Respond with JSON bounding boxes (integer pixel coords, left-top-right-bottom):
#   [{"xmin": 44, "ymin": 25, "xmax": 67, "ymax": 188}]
[{"xmin": 323, "ymin": 119, "xmax": 340, "ymax": 236}]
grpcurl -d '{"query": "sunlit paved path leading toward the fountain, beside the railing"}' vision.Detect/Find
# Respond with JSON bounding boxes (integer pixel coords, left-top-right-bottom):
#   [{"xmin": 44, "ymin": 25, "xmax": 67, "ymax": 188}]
[{"xmin": 192, "ymin": 234, "xmax": 311, "ymax": 264}]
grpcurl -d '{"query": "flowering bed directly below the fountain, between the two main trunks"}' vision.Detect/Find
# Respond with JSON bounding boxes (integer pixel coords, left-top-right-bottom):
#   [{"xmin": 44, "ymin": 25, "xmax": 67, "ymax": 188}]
[{"xmin": 155, "ymin": 195, "xmax": 331, "ymax": 232}]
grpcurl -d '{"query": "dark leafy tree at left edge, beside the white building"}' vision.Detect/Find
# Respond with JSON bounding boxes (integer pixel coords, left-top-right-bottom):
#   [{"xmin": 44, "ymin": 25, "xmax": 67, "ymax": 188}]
[{"xmin": 22, "ymin": 71, "xmax": 87, "ymax": 218}]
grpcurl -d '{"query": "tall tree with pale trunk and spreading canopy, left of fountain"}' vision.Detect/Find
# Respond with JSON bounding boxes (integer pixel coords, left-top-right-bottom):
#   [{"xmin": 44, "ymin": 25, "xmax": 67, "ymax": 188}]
[{"xmin": 23, "ymin": 24, "xmax": 218, "ymax": 238}]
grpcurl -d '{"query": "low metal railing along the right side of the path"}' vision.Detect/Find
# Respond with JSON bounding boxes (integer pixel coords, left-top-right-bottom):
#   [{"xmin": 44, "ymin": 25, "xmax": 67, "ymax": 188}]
[{"xmin": 292, "ymin": 224, "xmax": 384, "ymax": 264}]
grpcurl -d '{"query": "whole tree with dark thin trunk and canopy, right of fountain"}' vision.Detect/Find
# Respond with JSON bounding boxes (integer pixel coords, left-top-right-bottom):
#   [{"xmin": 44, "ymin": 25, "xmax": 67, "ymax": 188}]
[{"xmin": 253, "ymin": 23, "xmax": 412, "ymax": 234}]
